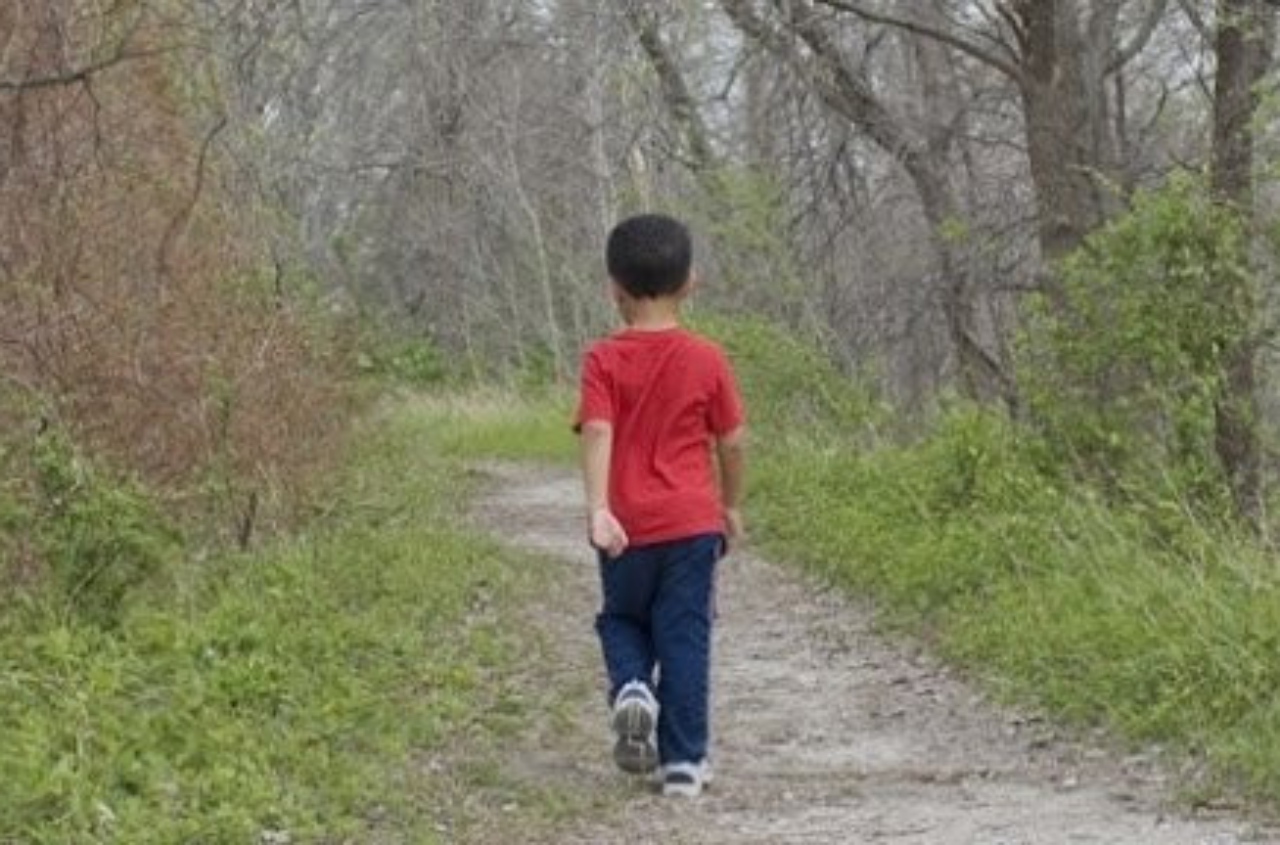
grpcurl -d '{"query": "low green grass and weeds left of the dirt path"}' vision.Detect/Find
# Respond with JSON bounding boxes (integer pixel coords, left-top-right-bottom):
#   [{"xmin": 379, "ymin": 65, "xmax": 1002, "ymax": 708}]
[{"xmin": 0, "ymin": 403, "xmax": 565, "ymax": 845}]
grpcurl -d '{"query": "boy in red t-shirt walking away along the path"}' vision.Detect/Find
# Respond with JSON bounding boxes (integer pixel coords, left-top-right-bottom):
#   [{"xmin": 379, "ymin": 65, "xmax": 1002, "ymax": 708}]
[{"xmin": 576, "ymin": 215, "xmax": 742, "ymax": 798}]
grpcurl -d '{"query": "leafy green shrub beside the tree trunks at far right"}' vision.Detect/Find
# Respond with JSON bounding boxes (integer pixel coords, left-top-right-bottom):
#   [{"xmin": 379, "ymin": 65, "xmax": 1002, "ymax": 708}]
[{"xmin": 1019, "ymin": 167, "xmax": 1256, "ymax": 511}]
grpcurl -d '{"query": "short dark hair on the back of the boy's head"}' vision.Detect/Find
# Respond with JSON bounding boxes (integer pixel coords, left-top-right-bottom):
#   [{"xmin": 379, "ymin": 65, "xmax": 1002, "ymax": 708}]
[{"xmin": 604, "ymin": 214, "xmax": 694, "ymax": 300}]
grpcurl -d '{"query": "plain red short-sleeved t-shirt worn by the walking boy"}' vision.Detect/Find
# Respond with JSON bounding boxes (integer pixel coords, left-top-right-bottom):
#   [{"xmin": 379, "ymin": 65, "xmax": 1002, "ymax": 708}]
[{"xmin": 576, "ymin": 328, "xmax": 742, "ymax": 545}]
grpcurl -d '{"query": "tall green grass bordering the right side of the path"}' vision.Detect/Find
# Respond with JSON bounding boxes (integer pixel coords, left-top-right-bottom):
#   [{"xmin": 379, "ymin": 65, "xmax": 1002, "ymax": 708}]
[{"xmin": 749, "ymin": 411, "xmax": 1280, "ymax": 805}]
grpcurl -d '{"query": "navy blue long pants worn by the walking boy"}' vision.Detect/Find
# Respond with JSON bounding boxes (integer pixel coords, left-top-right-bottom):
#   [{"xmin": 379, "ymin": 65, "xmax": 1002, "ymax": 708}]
[{"xmin": 595, "ymin": 534, "xmax": 724, "ymax": 764}]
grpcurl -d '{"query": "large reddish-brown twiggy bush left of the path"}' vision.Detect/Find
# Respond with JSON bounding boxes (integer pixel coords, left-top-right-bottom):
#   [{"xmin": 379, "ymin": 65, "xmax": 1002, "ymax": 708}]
[{"xmin": 0, "ymin": 6, "xmax": 347, "ymax": 540}]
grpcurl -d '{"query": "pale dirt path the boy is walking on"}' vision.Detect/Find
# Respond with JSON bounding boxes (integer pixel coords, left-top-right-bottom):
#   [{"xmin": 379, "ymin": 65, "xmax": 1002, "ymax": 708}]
[{"xmin": 476, "ymin": 466, "xmax": 1280, "ymax": 845}]
